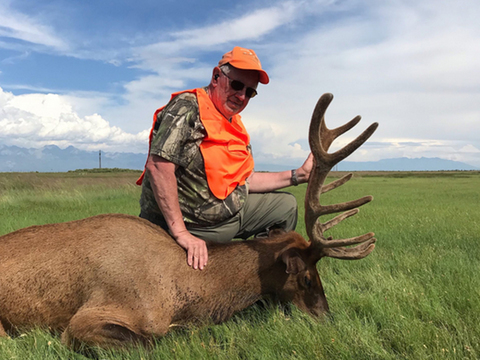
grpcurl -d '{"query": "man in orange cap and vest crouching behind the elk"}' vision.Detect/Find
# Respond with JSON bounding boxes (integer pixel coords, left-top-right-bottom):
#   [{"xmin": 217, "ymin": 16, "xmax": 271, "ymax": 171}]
[{"xmin": 137, "ymin": 47, "xmax": 313, "ymax": 269}]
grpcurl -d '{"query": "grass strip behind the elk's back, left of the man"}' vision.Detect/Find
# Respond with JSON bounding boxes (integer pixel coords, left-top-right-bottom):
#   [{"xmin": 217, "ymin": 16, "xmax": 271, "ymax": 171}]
[{"xmin": 0, "ymin": 171, "xmax": 140, "ymax": 234}]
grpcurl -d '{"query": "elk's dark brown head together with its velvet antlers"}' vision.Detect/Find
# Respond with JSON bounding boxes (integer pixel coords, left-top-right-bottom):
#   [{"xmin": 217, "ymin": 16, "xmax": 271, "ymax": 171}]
[{"xmin": 282, "ymin": 94, "xmax": 378, "ymax": 316}]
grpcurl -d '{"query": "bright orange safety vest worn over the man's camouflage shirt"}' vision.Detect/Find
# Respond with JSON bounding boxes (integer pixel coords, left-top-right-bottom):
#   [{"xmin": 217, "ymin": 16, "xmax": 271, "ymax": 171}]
[{"xmin": 137, "ymin": 88, "xmax": 254, "ymax": 200}]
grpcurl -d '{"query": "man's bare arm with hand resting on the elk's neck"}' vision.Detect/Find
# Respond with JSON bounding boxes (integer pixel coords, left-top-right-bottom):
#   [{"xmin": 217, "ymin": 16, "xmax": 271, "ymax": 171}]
[{"xmin": 146, "ymin": 155, "xmax": 208, "ymax": 270}]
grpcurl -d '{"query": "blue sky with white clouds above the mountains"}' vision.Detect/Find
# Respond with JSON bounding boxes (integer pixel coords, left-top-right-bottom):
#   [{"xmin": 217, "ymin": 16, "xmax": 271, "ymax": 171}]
[{"xmin": 0, "ymin": 0, "xmax": 480, "ymax": 168}]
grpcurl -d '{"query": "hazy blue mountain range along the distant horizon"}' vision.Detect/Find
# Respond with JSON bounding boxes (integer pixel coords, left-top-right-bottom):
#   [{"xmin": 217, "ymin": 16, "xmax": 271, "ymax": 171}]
[{"xmin": 0, "ymin": 145, "xmax": 478, "ymax": 172}]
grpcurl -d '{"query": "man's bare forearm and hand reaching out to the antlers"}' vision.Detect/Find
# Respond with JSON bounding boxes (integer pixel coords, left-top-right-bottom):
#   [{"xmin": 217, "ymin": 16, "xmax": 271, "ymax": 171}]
[{"xmin": 248, "ymin": 153, "xmax": 313, "ymax": 193}]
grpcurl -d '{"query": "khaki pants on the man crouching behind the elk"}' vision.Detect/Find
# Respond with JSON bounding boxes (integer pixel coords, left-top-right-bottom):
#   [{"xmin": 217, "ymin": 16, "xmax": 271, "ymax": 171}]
[{"xmin": 187, "ymin": 192, "xmax": 298, "ymax": 242}]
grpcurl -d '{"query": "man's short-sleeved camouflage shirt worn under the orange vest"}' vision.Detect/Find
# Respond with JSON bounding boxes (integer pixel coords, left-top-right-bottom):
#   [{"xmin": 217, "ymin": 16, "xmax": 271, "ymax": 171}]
[{"xmin": 140, "ymin": 93, "xmax": 248, "ymax": 226}]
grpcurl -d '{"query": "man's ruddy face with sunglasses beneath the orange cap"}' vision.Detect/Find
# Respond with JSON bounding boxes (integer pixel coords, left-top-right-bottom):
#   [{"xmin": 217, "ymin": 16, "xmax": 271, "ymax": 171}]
[{"xmin": 212, "ymin": 67, "xmax": 258, "ymax": 119}]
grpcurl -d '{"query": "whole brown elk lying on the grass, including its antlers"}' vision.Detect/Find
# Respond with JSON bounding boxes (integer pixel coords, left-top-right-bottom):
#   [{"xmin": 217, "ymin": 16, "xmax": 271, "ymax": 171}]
[{"xmin": 0, "ymin": 94, "xmax": 377, "ymax": 346}]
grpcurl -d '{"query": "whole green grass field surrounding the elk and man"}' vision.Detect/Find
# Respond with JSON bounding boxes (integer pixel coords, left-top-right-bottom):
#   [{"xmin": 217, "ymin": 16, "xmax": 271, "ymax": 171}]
[{"xmin": 0, "ymin": 172, "xmax": 480, "ymax": 360}]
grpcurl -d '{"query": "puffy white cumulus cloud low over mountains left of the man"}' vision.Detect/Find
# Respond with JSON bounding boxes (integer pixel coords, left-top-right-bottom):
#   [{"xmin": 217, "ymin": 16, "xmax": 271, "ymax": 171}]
[{"xmin": 0, "ymin": 88, "xmax": 148, "ymax": 152}]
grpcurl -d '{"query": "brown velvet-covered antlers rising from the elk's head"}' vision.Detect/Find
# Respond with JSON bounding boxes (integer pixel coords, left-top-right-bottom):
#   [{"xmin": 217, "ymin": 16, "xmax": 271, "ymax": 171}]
[{"xmin": 305, "ymin": 94, "xmax": 378, "ymax": 260}]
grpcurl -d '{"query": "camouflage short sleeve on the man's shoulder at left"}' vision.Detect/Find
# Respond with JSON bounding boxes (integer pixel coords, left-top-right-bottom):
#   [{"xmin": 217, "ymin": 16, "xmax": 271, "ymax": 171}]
[{"xmin": 150, "ymin": 93, "xmax": 205, "ymax": 167}]
